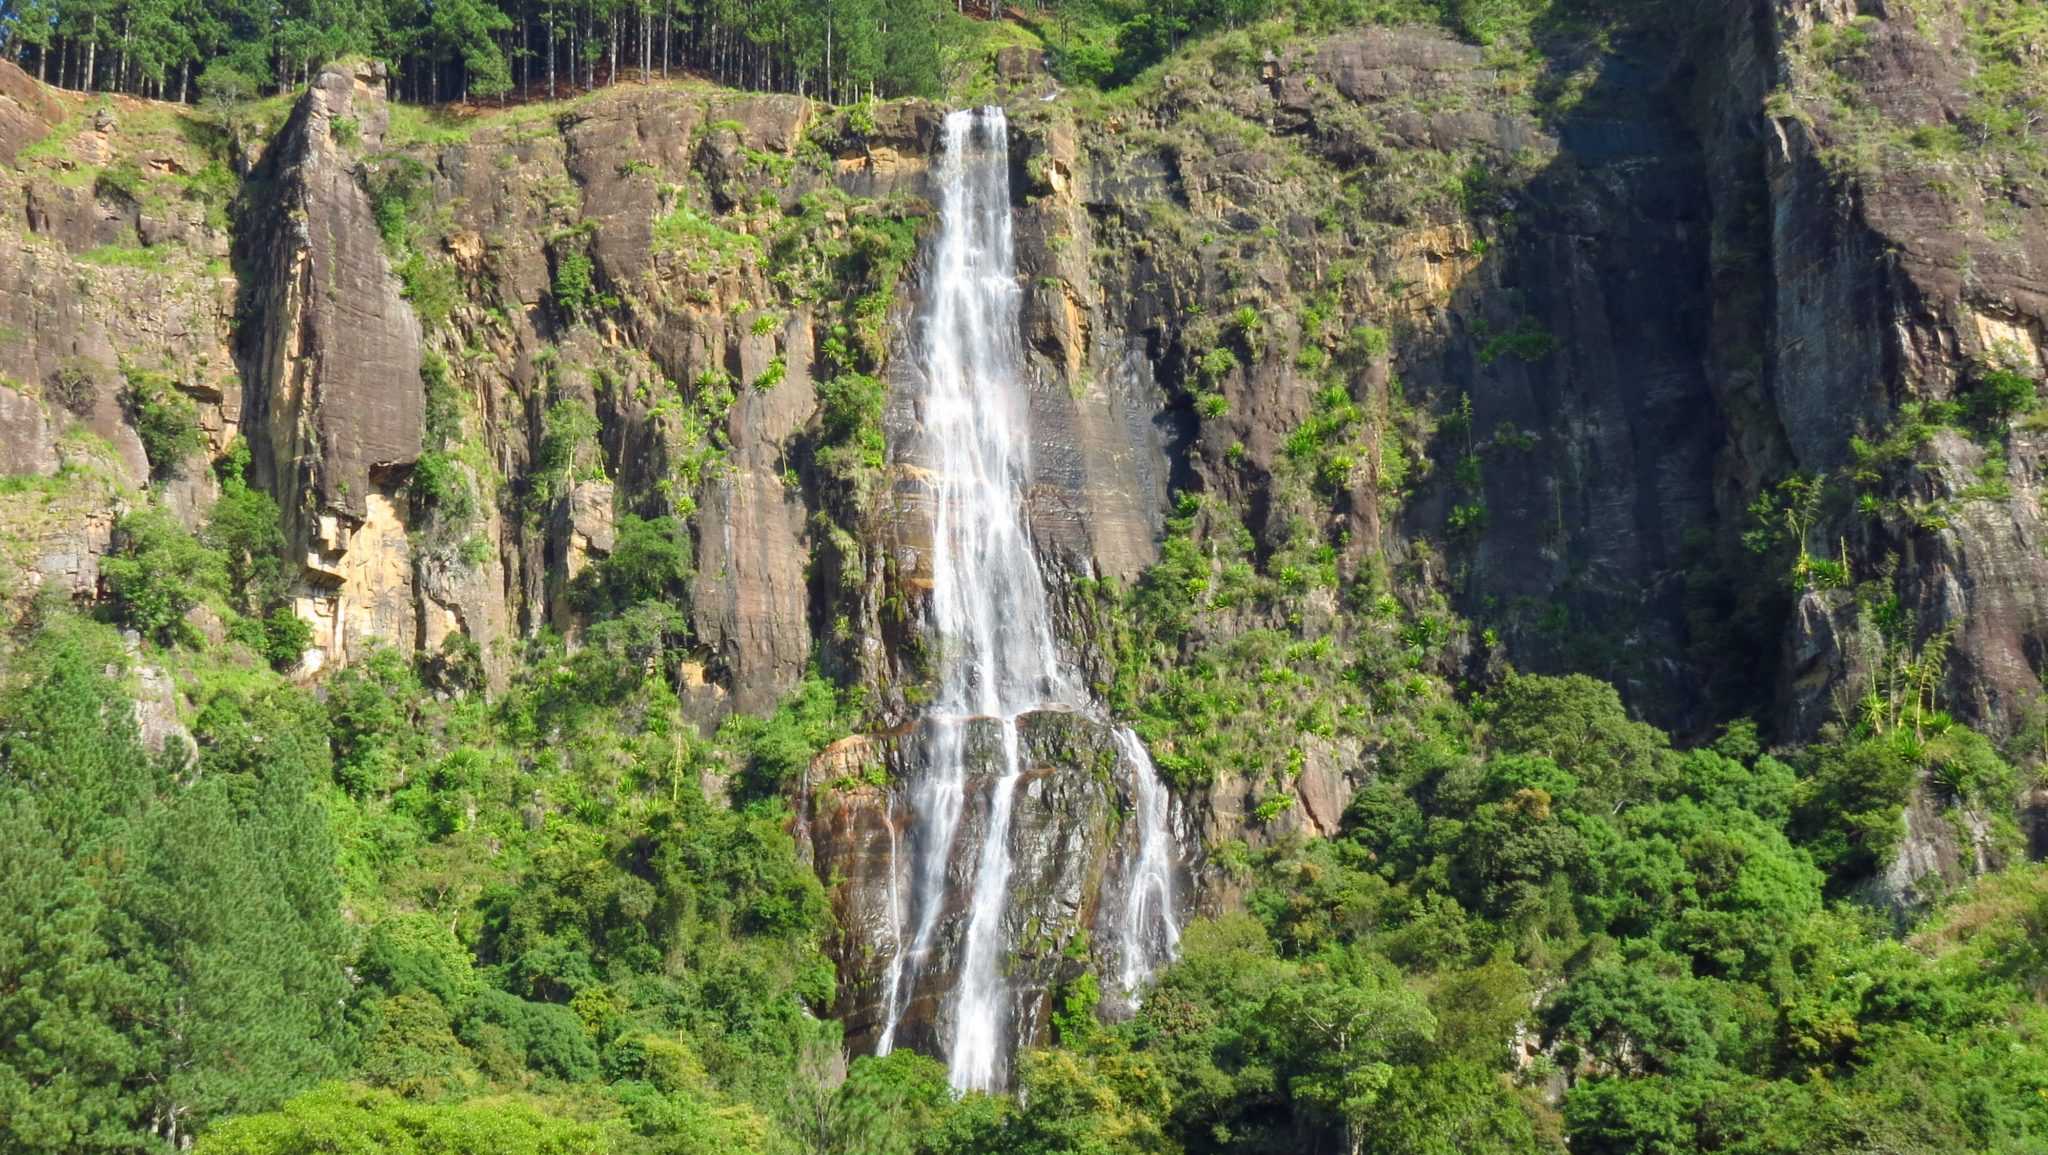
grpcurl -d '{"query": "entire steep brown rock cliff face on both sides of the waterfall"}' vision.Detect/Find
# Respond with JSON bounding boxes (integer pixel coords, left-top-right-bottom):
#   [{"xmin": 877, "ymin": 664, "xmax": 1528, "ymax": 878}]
[{"xmin": 0, "ymin": 0, "xmax": 2048, "ymax": 1073}]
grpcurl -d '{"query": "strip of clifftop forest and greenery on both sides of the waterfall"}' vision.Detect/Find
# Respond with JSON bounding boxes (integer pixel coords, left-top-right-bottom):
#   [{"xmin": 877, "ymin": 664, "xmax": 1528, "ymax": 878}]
[{"xmin": 0, "ymin": 0, "xmax": 1564, "ymax": 104}]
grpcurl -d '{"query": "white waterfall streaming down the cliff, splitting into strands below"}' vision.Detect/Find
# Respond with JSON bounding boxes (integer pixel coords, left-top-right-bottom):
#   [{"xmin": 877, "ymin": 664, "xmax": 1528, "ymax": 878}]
[{"xmin": 874, "ymin": 106, "xmax": 1180, "ymax": 1089}]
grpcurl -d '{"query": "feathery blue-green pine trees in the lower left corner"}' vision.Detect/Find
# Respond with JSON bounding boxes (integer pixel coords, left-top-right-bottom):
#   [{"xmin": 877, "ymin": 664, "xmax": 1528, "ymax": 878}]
[{"xmin": 0, "ymin": 631, "xmax": 346, "ymax": 1151}]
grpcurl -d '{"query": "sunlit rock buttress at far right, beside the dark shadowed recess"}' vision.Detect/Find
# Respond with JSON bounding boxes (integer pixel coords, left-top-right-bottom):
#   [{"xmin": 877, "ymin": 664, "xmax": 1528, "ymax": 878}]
[{"xmin": 1765, "ymin": 4, "xmax": 2048, "ymax": 733}]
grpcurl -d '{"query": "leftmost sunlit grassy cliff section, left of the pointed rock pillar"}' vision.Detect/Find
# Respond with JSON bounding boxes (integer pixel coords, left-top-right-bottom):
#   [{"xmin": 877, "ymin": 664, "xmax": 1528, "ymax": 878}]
[{"xmin": 0, "ymin": 63, "xmax": 242, "ymax": 600}]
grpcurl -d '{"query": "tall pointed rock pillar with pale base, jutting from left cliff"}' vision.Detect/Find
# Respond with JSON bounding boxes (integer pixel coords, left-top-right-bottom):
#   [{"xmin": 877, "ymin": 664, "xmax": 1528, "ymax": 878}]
[{"xmin": 236, "ymin": 70, "xmax": 426, "ymax": 668}]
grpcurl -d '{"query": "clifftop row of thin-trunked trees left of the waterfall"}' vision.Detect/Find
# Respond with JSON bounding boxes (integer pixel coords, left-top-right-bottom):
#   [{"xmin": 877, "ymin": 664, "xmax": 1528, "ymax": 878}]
[{"xmin": 0, "ymin": 0, "xmax": 965, "ymax": 102}]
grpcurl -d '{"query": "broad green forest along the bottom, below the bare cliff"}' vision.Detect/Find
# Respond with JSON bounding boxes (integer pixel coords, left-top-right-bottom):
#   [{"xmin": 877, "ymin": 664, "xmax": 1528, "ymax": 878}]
[{"xmin": 0, "ymin": 495, "xmax": 2048, "ymax": 1155}]
